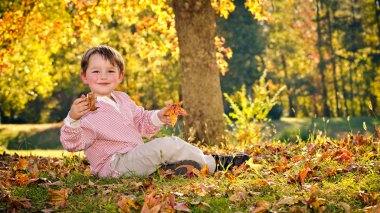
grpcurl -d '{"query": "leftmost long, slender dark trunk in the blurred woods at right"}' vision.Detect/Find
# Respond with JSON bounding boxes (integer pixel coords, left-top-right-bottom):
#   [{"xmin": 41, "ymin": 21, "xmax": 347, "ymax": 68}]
[{"xmin": 316, "ymin": 0, "xmax": 331, "ymax": 117}]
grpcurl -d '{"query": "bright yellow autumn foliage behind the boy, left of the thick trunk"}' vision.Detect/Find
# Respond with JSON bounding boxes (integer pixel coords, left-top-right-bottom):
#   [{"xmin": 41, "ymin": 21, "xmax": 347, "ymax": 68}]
[{"xmin": 0, "ymin": 0, "xmax": 180, "ymax": 123}]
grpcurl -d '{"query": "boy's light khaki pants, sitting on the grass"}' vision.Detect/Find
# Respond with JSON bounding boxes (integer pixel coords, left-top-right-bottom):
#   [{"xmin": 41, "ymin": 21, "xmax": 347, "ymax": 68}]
[{"xmin": 111, "ymin": 136, "xmax": 216, "ymax": 177}]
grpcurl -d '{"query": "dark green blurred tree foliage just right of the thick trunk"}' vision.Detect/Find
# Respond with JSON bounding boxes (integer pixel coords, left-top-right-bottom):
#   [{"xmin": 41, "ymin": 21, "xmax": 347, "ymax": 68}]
[{"xmin": 217, "ymin": 0, "xmax": 267, "ymax": 96}]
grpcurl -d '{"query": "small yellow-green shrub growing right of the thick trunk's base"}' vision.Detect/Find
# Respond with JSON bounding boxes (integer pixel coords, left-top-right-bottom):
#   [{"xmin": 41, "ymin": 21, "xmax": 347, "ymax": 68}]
[{"xmin": 224, "ymin": 72, "xmax": 285, "ymax": 145}]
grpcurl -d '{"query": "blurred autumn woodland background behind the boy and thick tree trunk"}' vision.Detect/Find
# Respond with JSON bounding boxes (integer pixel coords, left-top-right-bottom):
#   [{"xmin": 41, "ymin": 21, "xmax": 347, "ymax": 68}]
[{"xmin": 0, "ymin": 0, "xmax": 380, "ymax": 149}]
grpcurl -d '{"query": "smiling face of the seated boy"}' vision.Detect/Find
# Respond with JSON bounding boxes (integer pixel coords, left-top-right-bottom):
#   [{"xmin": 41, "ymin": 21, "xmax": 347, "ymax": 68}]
[{"xmin": 81, "ymin": 54, "xmax": 124, "ymax": 97}]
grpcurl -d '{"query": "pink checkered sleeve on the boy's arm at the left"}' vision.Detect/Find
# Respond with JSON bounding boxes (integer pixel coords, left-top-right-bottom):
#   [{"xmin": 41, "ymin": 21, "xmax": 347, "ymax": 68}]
[{"xmin": 60, "ymin": 117, "xmax": 96, "ymax": 152}]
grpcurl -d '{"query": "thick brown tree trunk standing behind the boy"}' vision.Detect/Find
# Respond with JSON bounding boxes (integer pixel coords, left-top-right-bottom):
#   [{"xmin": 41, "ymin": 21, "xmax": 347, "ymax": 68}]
[{"xmin": 173, "ymin": 0, "xmax": 226, "ymax": 145}]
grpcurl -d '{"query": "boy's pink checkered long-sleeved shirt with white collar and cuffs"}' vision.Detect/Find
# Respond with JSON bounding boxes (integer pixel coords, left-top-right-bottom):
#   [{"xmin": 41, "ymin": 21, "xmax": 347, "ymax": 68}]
[{"xmin": 60, "ymin": 91, "xmax": 162, "ymax": 177}]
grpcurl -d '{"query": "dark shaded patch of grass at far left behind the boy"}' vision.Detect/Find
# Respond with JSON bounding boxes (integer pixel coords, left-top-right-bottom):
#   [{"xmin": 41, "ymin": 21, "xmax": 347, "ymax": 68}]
[{"xmin": 7, "ymin": 127, "xmax": 63, "ymax": 150}]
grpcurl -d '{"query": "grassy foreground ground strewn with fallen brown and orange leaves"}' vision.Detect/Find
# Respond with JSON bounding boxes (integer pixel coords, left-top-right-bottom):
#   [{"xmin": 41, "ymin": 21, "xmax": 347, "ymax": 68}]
[{"xmin": 0, "ymin": 135, "xmax": 380, "ymax": 212}]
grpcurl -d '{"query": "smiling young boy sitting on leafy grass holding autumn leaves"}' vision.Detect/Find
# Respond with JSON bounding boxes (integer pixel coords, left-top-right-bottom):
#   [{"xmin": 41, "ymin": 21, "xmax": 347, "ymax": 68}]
[{"xmin": 60, "ymin": 46, "xmax": 248, "ymax": 177}]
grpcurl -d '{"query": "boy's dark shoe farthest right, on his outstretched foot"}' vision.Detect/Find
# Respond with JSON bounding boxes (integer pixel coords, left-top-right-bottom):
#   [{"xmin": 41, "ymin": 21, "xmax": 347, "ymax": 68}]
[{"xmin": 212, "ymin": 154, "xmax": 249, "ymax": 171}]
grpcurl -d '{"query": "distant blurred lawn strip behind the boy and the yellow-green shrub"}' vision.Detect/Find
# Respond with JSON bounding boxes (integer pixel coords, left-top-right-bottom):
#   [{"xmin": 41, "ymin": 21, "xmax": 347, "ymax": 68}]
[{"xmin": 0, "ymin": 117, "xmax": 380, "ymax": 156}]
